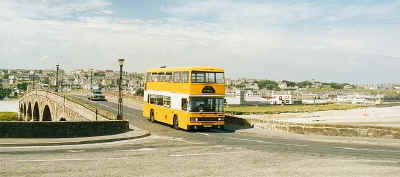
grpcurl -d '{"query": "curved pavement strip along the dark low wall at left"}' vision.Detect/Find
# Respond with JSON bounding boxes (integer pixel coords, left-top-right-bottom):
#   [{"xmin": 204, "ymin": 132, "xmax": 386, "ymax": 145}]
[{"xmin": 0, "ymin": 127, "xmax": 150, "ymax": 147}]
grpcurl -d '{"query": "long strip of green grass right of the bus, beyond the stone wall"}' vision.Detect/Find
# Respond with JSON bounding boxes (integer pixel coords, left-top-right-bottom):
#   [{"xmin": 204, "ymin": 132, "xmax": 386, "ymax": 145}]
[{"xmin": 225, "ymin": 104, "xmax": 362, "ymax": 115}]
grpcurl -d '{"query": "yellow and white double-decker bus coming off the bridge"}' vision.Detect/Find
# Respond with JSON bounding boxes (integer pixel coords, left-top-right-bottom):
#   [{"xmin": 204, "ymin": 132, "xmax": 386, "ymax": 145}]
[{"xmin": 143, "ymin": 67, "xmax": 225, "ymax": 130}]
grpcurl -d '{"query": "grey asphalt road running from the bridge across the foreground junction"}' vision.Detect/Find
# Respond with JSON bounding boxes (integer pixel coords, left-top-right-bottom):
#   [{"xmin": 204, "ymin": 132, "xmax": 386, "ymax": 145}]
[{"xmin": 0, "ymin": 98, "xmax": 400, "ymax": 177}]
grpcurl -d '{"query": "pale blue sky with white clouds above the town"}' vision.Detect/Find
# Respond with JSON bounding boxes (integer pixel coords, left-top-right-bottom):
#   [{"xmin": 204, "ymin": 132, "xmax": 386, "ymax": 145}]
[{"xmin": 0, "ymin": 0, "xmax": 400, "ymax": 83}]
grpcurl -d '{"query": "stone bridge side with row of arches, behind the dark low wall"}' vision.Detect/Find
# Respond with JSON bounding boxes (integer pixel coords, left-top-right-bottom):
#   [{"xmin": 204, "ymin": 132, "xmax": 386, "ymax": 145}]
[{"xmin": 19, "ymin": 90, "xmax": 114, "ymax": 121}]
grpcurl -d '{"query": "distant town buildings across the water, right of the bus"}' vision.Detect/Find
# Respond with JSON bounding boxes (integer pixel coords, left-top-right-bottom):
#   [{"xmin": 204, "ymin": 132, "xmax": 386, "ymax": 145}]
[{"xmin": 226, "ymin": 78, "xmax": 390, "ymax": 105}]
